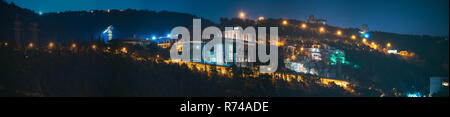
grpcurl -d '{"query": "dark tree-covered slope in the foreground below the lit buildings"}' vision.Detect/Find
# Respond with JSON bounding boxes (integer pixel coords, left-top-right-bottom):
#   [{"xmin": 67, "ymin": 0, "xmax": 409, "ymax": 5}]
[{"xmin": 0, "ymin": 48, "xmax": 364, "ymax": 97}]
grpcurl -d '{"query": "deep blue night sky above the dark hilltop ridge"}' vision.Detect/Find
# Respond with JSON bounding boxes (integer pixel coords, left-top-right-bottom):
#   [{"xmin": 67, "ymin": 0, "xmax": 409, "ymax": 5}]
[{"xmin": 6, "ymin": 0, "xmax": 449, "ymax": 36}]
